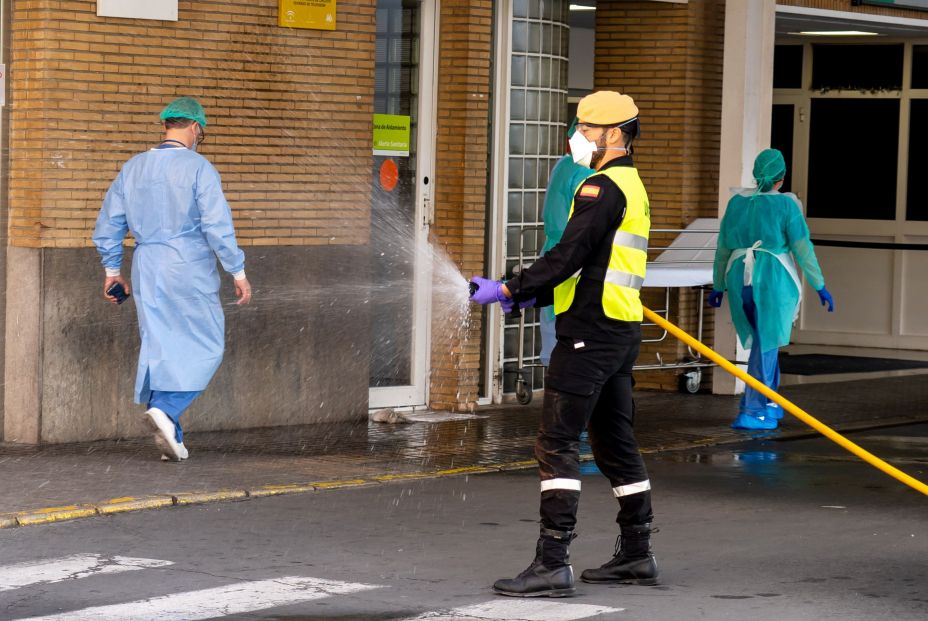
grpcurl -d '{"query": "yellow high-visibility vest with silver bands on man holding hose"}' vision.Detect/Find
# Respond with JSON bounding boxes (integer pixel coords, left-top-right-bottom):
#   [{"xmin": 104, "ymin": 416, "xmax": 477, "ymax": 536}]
[{"xmin": 554, "ymin": 166, "xmax": 651, "ymax": 322}]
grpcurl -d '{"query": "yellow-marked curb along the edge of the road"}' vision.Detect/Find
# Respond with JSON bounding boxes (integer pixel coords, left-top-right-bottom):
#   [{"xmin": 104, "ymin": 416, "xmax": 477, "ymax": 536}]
[{"xmin": 0, "ymin": 417, "xmax": 928, "ymax": 529}]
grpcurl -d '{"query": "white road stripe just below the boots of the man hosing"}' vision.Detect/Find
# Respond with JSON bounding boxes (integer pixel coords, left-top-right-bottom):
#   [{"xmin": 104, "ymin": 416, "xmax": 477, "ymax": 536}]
[{"xmin": 405, "ymin": 599, "xmax": 625, "ymax": 621}]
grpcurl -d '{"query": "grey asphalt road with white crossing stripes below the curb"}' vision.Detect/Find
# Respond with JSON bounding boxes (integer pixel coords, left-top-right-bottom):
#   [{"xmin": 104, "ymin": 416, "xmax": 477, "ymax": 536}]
[{"xmin": 0, "ymin": 426, "xmax": 928, "ymax": 621}]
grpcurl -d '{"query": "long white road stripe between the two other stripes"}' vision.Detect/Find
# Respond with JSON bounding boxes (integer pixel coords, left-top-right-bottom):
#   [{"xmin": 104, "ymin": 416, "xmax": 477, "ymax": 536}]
[{"xmin": 18, "ymin": 576, "xmax": 380, "ymax": 621}]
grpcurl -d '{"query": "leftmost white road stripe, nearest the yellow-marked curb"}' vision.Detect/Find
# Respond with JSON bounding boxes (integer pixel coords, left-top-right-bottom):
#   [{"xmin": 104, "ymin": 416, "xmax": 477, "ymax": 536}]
[{"xmin": 0, "ymin": 554, "xmax": 173, "ymax": 591}]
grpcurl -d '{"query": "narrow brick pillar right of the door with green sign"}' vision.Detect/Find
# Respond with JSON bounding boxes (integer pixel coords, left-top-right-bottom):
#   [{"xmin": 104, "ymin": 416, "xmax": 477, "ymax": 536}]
[{"xmin": 430, "ymin": 0, "xmax": 493, "ymax": 410}]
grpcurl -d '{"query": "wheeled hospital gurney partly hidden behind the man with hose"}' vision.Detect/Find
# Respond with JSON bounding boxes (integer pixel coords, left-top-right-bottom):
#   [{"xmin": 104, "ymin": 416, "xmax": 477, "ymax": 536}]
[{"xmin": 504, "ymin": 218, "xmax": 719, "ymax": 405}]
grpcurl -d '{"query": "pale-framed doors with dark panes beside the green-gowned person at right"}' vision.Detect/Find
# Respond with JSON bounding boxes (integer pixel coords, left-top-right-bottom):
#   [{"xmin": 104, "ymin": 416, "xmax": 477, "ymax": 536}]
[{"xmin": 772, "ymin": 37, "xmax": 928, "ymax": 349}]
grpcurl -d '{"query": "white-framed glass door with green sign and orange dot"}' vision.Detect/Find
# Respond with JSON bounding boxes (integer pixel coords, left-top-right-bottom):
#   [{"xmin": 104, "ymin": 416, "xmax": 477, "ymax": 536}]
[{"xmin": 370, "ymin": 0, "xmax": 435, "ymax": 408}]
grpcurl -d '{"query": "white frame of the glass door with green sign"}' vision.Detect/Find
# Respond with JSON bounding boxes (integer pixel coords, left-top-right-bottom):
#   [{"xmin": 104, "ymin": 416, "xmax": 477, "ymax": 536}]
[{"xmin": 368, "ymin": 0, "xmax": 440, "ymax": 409}]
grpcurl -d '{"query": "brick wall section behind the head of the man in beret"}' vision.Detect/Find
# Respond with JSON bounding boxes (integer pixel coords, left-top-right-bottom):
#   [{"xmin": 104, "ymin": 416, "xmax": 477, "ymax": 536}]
[{"xmin": 594, "ymin": 0, "xmax": 725, "ymax": 389}]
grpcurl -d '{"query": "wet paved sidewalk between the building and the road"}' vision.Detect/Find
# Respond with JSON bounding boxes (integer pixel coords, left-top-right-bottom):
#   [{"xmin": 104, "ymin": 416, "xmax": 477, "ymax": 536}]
[{"xmin": 0, "ymin": 376, "xmax": 928, "ymax": 527}]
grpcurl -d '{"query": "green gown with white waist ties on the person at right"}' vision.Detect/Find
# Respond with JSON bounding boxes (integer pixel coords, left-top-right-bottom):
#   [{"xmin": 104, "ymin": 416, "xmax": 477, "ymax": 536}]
[{"xmin": 713, "ymin": 190, "xmax": 825, "ymax": 352}]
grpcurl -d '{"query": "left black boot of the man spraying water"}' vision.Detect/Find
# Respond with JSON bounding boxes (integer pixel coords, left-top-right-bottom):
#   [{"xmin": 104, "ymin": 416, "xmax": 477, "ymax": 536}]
[{"xmin": 493, "ymin": 528, "xmax": 576, "ymax": 597}]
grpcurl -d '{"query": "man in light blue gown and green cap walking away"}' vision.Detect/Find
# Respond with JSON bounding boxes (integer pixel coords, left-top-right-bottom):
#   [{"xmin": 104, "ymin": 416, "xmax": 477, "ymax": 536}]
[{"xmin": 93, "ymin": 97, "xmax": 251, "ymax": 461}]
